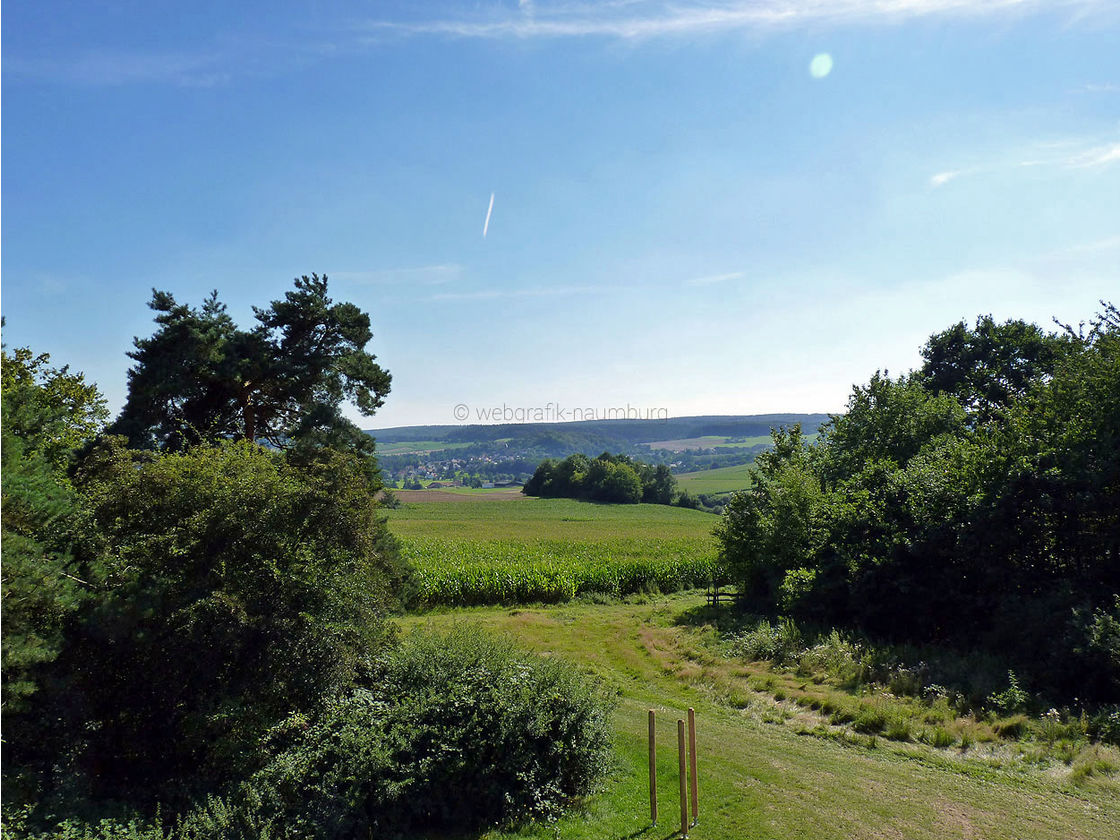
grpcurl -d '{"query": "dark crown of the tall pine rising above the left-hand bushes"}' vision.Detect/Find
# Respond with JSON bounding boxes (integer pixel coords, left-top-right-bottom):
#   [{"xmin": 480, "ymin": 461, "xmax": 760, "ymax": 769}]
[{"xmin": 113, "ymin": 274, "xmax": 390, "ymax": 468}]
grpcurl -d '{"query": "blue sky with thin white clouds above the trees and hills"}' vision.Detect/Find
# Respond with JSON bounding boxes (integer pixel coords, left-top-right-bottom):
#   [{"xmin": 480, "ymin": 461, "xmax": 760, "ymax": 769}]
[{"xmin": 2, "ymin": 0, "xmax": 1120, "ymax": 428}]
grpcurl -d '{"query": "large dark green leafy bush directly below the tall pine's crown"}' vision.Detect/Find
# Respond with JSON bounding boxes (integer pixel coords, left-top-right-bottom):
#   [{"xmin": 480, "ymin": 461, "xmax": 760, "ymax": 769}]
[{"xmin": 18, "ymin": 438, "xmax": 403, "ymax": 805}]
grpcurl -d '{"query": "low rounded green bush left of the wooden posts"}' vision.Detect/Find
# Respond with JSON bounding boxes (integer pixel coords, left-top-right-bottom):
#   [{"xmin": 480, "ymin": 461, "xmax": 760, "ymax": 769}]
[{"xmin": 243, "ymin": 631, "xmax": 610, "ymax": 838}]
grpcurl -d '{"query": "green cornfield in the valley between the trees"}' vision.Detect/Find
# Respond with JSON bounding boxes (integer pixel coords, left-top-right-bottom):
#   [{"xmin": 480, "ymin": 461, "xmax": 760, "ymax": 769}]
[{"xmin": 388, "ymin": 492, "xmax": 716, "ymax": 606}]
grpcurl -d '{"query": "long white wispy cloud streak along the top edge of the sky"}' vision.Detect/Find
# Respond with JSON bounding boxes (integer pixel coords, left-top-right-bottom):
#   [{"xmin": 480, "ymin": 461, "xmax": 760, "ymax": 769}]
[{"xmin": 362, "ymin": 0, "xmax": 1109, "ymax": 40}]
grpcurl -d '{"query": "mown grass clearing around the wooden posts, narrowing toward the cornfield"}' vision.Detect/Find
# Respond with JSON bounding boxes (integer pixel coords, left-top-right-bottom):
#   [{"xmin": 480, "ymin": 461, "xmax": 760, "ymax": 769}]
[{"xmin": 407, "ymin": 595, "xmax": 1120, "ymax": 840}]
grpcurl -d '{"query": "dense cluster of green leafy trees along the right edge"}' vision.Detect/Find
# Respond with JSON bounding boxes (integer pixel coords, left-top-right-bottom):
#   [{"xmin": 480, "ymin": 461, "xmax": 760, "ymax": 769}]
[{"xmin": 717, "ymin": 304, "xmax": 1120, "ymax": 702}]
